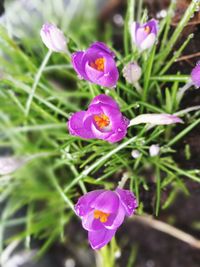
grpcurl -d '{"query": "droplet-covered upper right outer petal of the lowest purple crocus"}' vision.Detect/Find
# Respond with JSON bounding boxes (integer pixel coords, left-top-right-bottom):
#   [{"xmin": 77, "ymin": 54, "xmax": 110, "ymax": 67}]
[{"xmin": 115, "ymin": 188, "xmax": 137, "ymax": 216}]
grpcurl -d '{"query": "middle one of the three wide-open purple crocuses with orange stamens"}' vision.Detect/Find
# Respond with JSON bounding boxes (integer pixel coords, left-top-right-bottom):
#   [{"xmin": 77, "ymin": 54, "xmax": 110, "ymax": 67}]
[{"xmin": 68, "ymin": 94, "xmax": 129, "ymax": 143}]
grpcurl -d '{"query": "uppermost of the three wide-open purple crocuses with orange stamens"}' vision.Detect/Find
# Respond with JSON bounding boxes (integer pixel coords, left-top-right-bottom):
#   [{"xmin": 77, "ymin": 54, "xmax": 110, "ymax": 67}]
[{"xmin": 72, "ymin": 42, "xmax": 119, "ymax": 87}]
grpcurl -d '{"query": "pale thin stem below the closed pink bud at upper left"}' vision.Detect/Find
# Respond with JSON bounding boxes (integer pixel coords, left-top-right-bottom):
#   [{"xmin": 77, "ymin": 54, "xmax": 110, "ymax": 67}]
[{"xmin": 25, "ymin": 50, "xmax": 52, "ymax": 116}]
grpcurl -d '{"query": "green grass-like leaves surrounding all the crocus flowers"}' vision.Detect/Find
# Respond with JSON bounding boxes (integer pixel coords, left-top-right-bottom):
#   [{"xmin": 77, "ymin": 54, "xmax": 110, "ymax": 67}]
[{"xmin": 0, "ymin": 0, "xmax": 200, "ymax": 264}]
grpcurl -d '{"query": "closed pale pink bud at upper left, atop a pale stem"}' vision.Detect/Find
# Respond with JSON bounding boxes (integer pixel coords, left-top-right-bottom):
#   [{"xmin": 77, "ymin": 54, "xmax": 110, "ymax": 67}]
[{"xmin": 40, "ymin": 23, "xmax": 67, "ymax": 52}]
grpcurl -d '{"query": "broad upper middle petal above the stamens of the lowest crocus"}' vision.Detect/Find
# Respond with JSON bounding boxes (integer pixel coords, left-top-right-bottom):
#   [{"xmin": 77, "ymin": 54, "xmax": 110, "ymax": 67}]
[{"xmin": 91, "ymin": 191, "xmax": 119, "ymax": 214}]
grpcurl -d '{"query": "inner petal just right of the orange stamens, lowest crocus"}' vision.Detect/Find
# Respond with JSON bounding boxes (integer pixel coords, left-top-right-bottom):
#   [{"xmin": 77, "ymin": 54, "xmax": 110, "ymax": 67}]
[{"xmin": 103, "ymin": 204, "xmax": 125, "ymax": 230}]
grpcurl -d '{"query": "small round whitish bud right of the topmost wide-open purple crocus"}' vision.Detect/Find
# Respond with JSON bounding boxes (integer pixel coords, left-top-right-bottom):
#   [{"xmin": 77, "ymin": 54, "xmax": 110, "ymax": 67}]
[{"xmin": 123, "ymin": 62, "xmax": 142, "ymax": 84}]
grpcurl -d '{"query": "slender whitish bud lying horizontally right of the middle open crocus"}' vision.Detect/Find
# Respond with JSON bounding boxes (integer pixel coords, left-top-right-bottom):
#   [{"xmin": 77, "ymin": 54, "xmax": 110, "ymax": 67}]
[{"xmin": 129, "ymin": 113, "xmax": 183, "ymax": 126}]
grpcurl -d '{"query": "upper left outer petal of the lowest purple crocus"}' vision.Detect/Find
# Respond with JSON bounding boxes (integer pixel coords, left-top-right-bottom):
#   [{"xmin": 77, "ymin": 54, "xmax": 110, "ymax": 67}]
[{"xmin": 75, "ymin": 190, "xmax": 105, "ymax": 217}]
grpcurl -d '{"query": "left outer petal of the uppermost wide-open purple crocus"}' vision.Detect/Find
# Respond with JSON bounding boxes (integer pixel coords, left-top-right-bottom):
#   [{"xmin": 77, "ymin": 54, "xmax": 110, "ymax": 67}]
[{"xmin": 72, "ymin": 51, "xmax": 88, "ymax": 80}]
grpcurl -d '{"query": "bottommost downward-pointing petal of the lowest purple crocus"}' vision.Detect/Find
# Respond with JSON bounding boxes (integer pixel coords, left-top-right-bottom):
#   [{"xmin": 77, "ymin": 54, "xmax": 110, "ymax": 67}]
[{"xmin": 88, "ymin": 228, "xmax": 116, "ymax": 249}]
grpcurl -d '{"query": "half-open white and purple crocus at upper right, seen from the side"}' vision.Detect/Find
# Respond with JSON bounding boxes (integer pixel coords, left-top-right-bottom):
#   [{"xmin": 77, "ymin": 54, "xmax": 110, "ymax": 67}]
[{"xmin": 131, "ymin": 19, "xmax": 158, "ymax": 51}]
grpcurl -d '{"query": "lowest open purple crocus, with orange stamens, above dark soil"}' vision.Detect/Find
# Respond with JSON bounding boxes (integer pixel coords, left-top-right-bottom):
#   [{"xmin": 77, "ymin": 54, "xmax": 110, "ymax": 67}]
[{"xmin": 75, "ymin": 188, "xmax": 137, "ymax": 249}]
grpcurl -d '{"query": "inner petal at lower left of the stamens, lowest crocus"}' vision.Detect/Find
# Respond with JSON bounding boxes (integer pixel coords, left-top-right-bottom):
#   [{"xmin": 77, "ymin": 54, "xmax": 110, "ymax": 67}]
[{"xmin": 82, "ymin": 210, "xmax": 104, "ymax": 231}]
